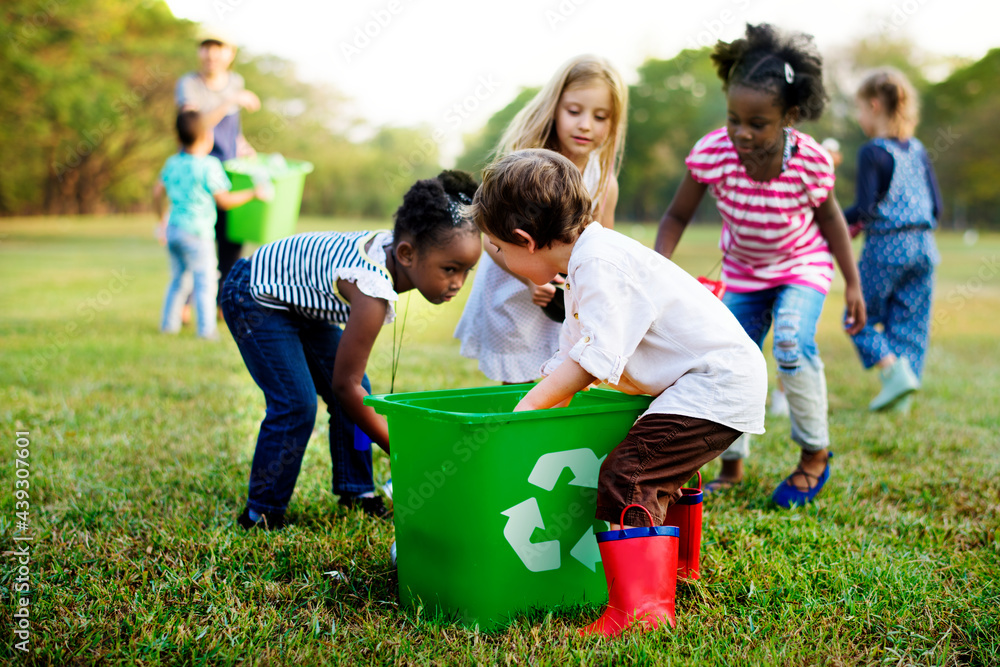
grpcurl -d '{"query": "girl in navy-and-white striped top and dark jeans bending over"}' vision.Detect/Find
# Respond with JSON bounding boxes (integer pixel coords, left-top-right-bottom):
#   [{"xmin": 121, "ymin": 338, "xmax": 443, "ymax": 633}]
[{"xmin": 222, "ymin": 171, "xmax": 482, "ymax": 530}]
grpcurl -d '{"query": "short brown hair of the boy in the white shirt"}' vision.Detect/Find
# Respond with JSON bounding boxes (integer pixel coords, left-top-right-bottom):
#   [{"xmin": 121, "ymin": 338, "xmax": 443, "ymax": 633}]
[{"xmin": 468, "ymin": 148, "xmax": 593, "ymax": 248}]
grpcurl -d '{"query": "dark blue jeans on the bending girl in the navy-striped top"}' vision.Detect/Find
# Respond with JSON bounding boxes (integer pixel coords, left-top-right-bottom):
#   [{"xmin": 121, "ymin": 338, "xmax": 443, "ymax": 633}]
[{"xmin": 222, "ymin": 259, "xmax": 375, "ymax": 512}]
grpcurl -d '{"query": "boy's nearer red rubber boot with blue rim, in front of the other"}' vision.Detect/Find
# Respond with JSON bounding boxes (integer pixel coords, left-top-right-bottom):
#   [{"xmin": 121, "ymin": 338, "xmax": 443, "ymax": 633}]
[{"xmin": 579, "ymin": 505, "xmax": 678, "ymax": 637}]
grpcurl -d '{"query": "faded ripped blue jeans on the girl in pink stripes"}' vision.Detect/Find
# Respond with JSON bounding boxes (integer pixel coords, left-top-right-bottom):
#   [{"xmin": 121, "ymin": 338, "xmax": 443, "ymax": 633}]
[{"xmin": 722, "ymin": 285, "xmax": 830, "ymax": 460}]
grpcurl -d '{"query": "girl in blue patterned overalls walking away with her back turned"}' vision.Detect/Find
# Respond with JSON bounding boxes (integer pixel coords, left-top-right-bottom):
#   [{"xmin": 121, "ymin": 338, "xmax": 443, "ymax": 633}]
[{"xmin": 845, "ymin": 68, "xmax": 941, "ymax": 412}]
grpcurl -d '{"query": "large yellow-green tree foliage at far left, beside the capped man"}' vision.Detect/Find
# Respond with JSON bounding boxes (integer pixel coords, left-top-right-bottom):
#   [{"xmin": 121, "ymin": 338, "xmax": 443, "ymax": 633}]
[{"xmin": 0, "ymin": 0, "xmax": 194, "ymax": 213}]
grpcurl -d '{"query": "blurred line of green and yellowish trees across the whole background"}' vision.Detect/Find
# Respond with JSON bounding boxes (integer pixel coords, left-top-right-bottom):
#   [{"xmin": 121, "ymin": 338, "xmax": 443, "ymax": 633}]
[{"xmin": 0, "ymin": 0, "xmax": 1000, "ymax": 228}]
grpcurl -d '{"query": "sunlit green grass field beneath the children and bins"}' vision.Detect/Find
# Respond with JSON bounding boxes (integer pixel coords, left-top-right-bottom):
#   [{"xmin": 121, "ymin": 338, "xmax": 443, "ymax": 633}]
[{"xmin": 0, "ymin": 217, "xmax": 1000, "ymax": 665}]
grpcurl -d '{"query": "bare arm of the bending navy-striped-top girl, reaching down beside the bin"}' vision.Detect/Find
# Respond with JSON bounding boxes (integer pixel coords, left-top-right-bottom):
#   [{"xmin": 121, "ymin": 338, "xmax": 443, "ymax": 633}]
[{"xmin": 331, "ymin": 280, "xmax": 389, "ymax": 452}]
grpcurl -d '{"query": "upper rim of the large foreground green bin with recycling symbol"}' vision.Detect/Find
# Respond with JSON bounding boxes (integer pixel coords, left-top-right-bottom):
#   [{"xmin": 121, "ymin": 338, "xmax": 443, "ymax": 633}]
[{"xmin": 364, "ymin": 384, "xmax": 652, "ymax": 424}]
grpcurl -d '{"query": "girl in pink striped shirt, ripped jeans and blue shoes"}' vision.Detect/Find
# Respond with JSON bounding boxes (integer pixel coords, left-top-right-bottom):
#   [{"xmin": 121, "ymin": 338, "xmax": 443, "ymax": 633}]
[{"xmin": 656, "ymin": 24, "xmax": 865, "ymax": 507}]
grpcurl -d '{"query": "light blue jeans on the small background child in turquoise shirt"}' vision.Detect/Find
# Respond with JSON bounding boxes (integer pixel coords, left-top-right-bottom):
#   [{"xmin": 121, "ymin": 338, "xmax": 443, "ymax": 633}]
[{"xmin": 160, "ymin": 225, "xmax": 216, "ymax": 338}]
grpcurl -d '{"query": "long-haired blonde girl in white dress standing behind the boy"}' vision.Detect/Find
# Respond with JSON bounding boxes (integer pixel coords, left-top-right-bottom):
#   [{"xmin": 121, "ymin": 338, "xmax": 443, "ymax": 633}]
[{"xmin": 455, "ymin": 55, "xmax": 628, "ymax": 383}]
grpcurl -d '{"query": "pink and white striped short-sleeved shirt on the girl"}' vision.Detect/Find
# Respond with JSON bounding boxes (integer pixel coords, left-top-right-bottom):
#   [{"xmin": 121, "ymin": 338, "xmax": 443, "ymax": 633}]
[{"xmin": 684, "ymin": 128, "xmax": 834, "ymax": 294}]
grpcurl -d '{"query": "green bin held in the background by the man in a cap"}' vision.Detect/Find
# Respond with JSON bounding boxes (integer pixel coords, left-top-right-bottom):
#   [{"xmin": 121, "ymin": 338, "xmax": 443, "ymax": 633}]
[{"xmin": 225, "ymin": 154, "xmax": 313, "ymax": 245}]
